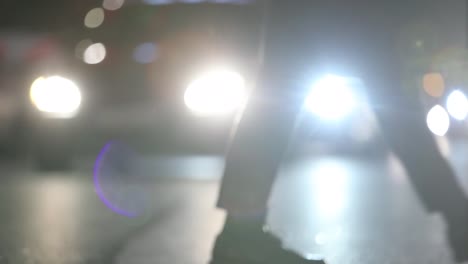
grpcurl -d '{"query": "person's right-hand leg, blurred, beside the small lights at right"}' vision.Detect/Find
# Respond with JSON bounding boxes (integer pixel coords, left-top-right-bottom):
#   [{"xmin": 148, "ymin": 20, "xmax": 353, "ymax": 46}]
[{"xmin": 364, "ymin": 62, "xmax": 468, "ymax": 261}]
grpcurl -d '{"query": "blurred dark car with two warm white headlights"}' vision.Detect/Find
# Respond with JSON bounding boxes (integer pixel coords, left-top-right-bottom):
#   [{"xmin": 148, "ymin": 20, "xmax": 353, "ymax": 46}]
[{"xmin": 0, "ymin": 3, "xmax": 257, "ymax": 169}]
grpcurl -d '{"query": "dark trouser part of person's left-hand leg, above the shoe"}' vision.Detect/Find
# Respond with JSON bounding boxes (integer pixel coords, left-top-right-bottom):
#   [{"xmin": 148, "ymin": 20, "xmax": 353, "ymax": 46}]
[{"xmin": 218, "ymin": 73, "xmax": 301, "ymax": 216}]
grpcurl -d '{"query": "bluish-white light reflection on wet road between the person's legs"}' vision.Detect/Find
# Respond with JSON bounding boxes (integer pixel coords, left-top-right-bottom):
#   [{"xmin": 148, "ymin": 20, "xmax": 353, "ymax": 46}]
[{"xmin": 270, "ymin": 158, "xmax": 450, "ymax": 264}]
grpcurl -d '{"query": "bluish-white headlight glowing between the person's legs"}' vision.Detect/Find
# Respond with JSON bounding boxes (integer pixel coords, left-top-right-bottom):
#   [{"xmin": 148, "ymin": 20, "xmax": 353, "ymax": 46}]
[{"xmin": 305, "ymin": 75, "xmax": 357, "ymax": 120}]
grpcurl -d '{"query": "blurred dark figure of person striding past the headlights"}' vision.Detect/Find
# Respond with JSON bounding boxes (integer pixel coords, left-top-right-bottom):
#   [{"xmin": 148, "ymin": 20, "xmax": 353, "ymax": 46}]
[{"xmin": 212, "ymin": 0, "xmax": 468, "ymax": 264}]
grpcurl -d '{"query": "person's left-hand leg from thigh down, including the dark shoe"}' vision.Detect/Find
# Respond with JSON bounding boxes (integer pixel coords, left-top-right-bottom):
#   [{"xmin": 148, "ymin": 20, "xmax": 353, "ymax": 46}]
[{"xmin": 212, "ymin": 71, "xmax": 322, "ymax": 263}]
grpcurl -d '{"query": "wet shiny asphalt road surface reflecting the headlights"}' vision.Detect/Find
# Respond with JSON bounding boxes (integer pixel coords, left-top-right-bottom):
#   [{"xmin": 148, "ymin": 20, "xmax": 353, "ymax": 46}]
[{"xmin": 0, "ymin": 138, "xmax": 468, "ymax": 264}]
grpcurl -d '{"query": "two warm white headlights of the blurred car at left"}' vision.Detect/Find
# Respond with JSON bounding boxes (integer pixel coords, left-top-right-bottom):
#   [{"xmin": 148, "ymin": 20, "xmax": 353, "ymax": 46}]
[{"xmin": 29, "ymin": 71, "xmax": 248, "ymax": 118}]
